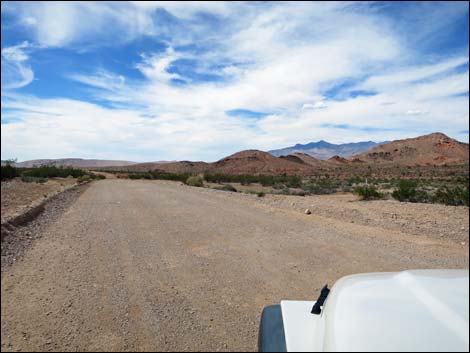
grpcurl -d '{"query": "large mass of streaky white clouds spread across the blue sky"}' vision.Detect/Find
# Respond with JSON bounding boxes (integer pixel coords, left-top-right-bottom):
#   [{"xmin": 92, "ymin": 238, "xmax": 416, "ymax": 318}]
[{"xmin": 2, "ymin": 2, "xmax": 469, "ymax": 160}]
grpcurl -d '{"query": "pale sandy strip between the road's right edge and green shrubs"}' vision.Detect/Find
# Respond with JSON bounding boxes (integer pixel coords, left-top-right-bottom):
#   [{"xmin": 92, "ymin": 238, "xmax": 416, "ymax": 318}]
[{"xmin": 257, "ymin": 194, "xmax": 469, "ymax": 245}]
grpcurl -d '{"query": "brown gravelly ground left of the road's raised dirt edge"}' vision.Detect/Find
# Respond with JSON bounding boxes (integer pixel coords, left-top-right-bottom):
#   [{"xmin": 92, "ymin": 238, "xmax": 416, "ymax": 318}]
[{"xmin": 1, "ymin": 178, "xmax": 76, "ymax": 223}]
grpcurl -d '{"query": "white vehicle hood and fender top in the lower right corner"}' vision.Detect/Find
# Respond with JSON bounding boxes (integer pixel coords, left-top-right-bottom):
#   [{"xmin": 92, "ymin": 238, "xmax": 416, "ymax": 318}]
[{"xmin": 281, "ymin": 270, "xmax": 469, "ymax": 351}]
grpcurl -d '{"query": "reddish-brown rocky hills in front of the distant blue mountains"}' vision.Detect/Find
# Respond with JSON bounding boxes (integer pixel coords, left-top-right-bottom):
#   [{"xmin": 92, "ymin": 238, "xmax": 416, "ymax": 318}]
[{"xmin": 114, "ymin": 133, "xmax": 469, "ymax": 175}]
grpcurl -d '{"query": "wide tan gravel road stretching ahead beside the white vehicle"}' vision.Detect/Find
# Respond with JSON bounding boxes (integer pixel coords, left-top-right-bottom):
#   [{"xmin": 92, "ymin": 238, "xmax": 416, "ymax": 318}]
[{"xmin": 1, "ymin": 179, "xmax": 469, "ymax": 351}]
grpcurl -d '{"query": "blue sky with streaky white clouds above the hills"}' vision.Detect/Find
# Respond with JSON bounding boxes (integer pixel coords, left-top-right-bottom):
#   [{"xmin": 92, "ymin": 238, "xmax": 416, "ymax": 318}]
[{"xmin": 1, "ymin": 1, "xmax": 469, "ymax": 161}]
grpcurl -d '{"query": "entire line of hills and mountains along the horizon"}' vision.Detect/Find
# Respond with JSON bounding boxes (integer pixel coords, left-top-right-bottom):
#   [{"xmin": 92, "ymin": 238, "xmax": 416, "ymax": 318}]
[{"xmin": 5, "ymin": 133, "xmax": 469, "ymax": 175}]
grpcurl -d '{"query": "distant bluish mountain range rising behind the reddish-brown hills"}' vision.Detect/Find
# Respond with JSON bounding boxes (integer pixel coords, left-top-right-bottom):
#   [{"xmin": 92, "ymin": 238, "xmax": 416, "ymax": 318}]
[{"xmin": 268, "ymin": 140, "xmax": 387, "ymax": 160}]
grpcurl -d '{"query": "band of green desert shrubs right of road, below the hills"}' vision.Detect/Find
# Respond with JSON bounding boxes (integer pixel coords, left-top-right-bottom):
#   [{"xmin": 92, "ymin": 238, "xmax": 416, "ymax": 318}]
[{"xmin": 104, "ymin": 166, "xmax": 468, "ymax": 205}]
